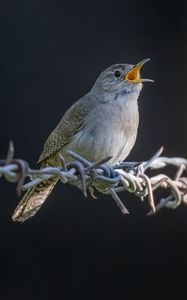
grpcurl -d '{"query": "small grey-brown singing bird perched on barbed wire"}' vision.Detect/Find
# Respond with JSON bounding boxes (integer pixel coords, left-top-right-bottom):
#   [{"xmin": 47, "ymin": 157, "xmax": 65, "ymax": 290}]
[{"xmin": 12, "ymin": 58, "xmax": 153, "ymax": 223}]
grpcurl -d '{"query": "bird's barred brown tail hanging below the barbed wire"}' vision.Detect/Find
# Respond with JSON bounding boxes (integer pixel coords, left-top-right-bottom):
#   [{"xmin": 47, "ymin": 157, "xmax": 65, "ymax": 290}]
[{"xmin": 12, "ymin": 177, "xmax": 58, "ymax": 222}]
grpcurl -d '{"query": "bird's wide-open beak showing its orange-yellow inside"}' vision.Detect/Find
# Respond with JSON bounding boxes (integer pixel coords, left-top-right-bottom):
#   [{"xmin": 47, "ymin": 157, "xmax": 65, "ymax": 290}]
[{"xmin": 124, "ymin": 58, "xmax": 154, "ymax": 83}]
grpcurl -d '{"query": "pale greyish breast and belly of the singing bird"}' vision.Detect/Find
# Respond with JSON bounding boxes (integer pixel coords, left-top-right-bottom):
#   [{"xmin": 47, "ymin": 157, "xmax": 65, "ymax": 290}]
[{"xmin": 64, "ymin": 99, "xmax": 139, "ymax": 163}]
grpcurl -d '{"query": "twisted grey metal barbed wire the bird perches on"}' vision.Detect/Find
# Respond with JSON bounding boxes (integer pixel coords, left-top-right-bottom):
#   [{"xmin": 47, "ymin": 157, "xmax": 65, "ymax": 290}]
[{"xmin": 0, "ymin": 142, "xmax": 187, "ymax": 215}]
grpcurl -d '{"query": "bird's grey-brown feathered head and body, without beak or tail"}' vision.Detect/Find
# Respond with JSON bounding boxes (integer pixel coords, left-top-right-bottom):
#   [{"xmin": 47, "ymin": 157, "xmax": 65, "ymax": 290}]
[{"xmin": 39, "ymin": 64, "xmax": 142, "ymax": 163}]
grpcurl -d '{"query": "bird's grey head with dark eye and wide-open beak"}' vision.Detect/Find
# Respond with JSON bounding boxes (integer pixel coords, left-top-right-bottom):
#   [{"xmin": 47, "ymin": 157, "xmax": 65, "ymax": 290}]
[{"xmin": 93, "ymin": 58, "xmax": 153, "ymax": 93}]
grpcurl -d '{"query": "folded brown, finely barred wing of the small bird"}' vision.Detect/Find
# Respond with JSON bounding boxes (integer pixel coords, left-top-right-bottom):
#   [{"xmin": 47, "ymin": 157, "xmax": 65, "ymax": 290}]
[{"xmin": 38, "ymin": 94, "xmax": 95, "ymax": 164}]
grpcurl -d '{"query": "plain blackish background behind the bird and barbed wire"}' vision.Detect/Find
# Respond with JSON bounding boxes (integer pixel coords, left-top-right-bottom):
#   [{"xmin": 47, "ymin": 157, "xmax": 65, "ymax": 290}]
[{"xmin": 0, "ymin": 0, "xmax": 187, "ymax": 300}]
